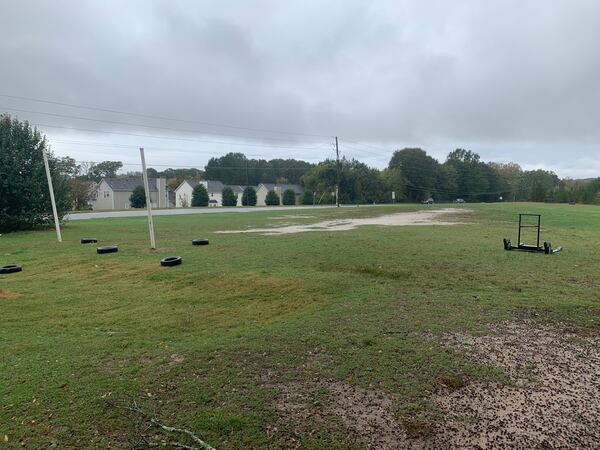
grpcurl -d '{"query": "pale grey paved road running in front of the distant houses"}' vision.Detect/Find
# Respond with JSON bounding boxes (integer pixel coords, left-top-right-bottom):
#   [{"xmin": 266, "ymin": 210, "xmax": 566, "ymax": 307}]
[{"xmin": 65, "ymin": 205, "xmax": 332, "ymax": 220}]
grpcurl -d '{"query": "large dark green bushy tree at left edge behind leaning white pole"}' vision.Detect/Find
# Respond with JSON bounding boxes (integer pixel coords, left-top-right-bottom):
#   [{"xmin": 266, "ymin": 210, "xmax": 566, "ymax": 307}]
[{"xmin": 0, "ymin": 115, "xmax": 71, "ymax": 233}]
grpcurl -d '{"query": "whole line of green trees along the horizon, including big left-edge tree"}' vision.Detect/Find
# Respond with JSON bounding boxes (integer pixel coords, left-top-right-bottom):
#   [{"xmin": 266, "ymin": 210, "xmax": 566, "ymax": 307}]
[{"xmin": 0, "ymin": 114, "xmax": 600, "ymax": 233}]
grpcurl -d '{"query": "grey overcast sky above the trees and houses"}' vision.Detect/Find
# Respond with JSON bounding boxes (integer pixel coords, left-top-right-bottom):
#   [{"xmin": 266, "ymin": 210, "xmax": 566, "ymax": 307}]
[{"xmin": 0, "ymin": 0, "xmax": 600, "ymax": 178}]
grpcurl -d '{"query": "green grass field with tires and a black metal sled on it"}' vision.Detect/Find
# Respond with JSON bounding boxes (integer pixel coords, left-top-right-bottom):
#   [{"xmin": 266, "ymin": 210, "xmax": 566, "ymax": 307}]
[{"xmin": 0, "ymin": 203, "xmax": 600, "ymax": 449}]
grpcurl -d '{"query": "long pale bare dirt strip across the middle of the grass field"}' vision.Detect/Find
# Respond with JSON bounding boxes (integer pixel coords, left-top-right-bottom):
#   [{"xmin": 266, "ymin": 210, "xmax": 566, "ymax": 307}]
[{"xmin": 216, "ymin": 208, "xmax": 470, "ymax": 236}]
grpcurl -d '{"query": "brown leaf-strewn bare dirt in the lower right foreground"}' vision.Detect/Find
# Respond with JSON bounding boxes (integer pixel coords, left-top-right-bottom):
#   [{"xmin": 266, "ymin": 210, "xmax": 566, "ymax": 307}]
[{"xmin": 271, "ymin": 321, "xmax": 600, "ymax": 449}]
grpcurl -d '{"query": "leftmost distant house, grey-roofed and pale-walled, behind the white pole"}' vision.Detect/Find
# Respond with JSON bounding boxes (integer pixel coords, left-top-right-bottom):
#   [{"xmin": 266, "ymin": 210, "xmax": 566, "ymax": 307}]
[{"xmin": 90, "ymin": 177, "xmax": 173, "ymax": 210}]
